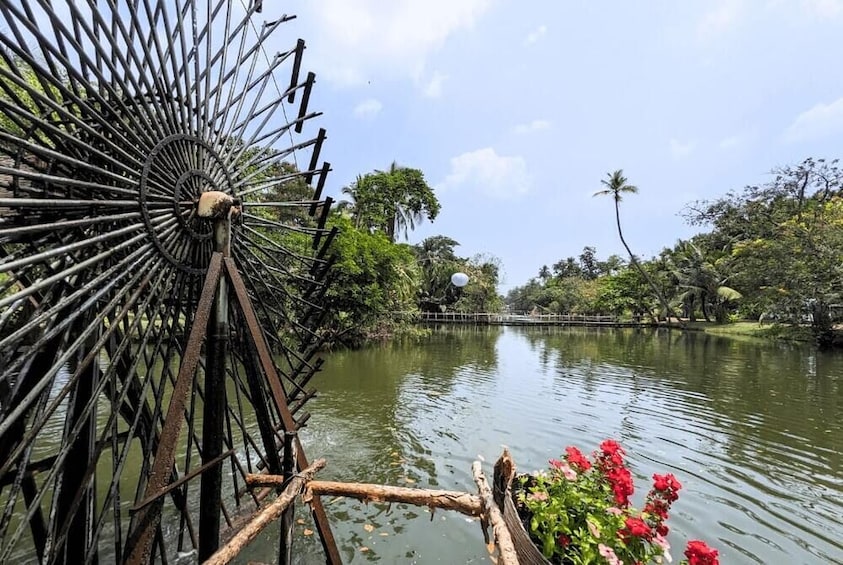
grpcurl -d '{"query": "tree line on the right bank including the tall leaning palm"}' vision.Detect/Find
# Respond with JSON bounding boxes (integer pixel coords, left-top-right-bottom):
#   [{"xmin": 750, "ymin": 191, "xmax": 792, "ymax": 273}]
[{"xmin": 506, "ymin": 158, "xmax": 843, "ymax": 343}]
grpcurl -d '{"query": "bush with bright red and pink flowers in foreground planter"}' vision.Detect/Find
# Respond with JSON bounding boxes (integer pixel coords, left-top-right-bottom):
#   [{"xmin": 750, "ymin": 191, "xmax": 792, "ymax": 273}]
[{"xmin": 517, "ymin": 439, "xmax": 719, "ymax": 565}]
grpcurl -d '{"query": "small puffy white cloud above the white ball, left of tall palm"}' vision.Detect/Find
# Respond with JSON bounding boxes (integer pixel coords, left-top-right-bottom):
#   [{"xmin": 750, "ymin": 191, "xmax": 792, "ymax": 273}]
[{"xmin": 438, "ymin": 147, "xmax": 532, "ymax": 199}]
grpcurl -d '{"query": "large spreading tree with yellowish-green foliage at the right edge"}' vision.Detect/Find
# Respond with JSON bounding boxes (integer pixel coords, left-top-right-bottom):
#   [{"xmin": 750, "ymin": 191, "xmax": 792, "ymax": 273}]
[{"xmin": 687, "ymin": 158, "xmax": 843, "ymax": 344}]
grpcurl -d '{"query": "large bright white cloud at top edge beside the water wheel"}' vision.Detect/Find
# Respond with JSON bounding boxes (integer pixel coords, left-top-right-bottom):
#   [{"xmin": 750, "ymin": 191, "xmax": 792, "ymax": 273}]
[{"xmin": 297, "ymin": 0, "xmax": 492, "ymax": 86}]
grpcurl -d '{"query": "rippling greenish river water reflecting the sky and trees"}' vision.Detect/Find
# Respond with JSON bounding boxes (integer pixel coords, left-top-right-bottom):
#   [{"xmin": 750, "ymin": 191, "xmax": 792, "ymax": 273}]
[{"xmin": 244, "ymin": 327, "xmax": 843, "ymax": 564}]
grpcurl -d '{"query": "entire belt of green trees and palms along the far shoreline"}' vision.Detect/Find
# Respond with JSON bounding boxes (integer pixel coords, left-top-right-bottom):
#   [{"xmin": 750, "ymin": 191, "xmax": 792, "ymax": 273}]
[{"xmin": 241, "ymin": 153, "xmax": 843, "ymax": 349}]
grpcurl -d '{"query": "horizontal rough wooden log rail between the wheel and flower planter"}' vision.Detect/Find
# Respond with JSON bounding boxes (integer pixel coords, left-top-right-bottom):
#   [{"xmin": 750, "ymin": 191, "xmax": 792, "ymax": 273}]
[{"xmin": 298, "ymin": 475, "xmax": 483, "ymax": 516}]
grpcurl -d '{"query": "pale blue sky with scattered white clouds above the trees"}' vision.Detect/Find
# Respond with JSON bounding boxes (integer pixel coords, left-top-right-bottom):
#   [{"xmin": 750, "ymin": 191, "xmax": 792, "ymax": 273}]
[{"xmin": 280, "ymin": 0, "xmax": 843, "ymax": 292}]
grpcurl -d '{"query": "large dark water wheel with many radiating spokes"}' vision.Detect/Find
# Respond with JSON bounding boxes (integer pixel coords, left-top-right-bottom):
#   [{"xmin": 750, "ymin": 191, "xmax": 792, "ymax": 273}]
[{"xmin": 0, "ymin": 0, "xmax": 333, "ymax": 564}]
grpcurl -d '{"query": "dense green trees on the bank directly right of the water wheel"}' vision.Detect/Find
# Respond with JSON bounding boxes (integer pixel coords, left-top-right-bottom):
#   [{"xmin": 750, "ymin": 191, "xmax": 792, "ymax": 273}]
[{"xmin": 262, "ymin": 163, "xmax": 502, "ymax": 346}]
